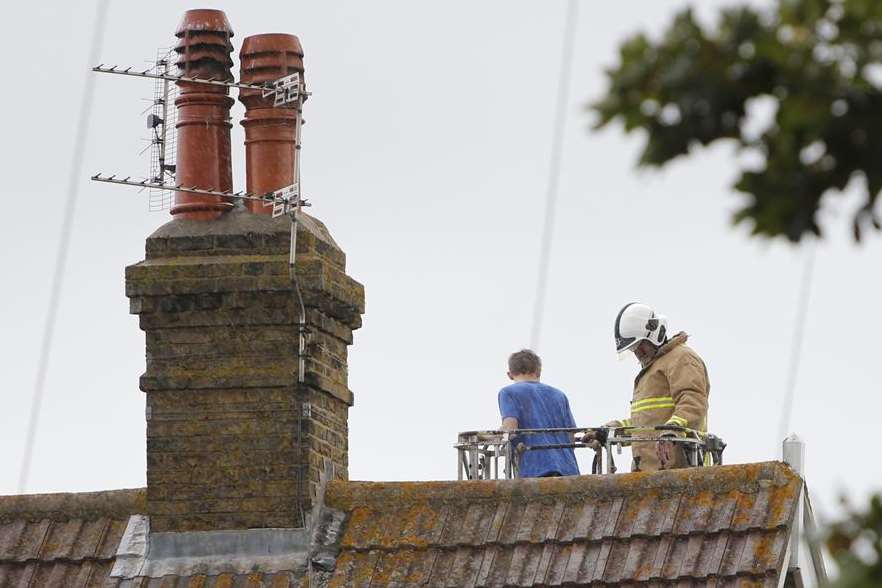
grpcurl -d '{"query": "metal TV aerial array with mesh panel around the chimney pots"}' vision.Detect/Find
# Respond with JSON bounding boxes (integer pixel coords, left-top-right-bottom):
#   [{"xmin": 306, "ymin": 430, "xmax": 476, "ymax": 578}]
[{"xmin": 91, "ymin": 48, "xmax": 310, "ymax": 218}]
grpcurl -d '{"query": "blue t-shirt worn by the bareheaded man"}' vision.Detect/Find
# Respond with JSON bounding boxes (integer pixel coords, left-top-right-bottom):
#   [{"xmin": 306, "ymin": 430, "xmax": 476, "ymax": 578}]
[{"xmin": 499, "ymin": 382, "xmax": 579, "ymax": 478}]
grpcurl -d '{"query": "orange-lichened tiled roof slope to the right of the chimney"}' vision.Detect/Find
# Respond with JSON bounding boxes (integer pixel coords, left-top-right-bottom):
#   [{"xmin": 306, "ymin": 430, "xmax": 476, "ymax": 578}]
[{"xmin": 314, "ymin": 462, "xmax": 802, "ymax": 587}]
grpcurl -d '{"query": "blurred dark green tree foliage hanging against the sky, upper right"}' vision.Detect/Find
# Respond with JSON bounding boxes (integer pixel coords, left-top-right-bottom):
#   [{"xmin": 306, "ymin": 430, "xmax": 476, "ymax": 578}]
[{"xmin": 591, "ymin": 0, "xmax": 882, "ymax": 242}]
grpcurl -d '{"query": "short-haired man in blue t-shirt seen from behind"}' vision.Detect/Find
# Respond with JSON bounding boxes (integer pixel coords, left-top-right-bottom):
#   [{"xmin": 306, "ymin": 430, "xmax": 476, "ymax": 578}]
[{"xmin": 499, "ymin": 349, "xmax": 579, "ymax": 478}]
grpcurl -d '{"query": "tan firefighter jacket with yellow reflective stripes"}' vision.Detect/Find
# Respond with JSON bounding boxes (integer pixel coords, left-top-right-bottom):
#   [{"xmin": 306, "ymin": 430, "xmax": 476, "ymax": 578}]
[{"xmin": 619, "ymin": 333, "xmax": 710, "ymax": 472}]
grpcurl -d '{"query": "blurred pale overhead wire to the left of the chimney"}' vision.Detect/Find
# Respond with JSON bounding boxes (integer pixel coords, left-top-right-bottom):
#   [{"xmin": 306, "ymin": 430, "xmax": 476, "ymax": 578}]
[{"xmin": 18, "ymin": 0, "xmax": 109, "ymax": 494}]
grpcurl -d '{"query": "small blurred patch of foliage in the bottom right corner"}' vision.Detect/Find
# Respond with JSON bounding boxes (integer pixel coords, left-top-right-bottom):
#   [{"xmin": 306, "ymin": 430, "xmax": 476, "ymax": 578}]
[{"xmin": 827, "ymin": 494, "xmax": 882, "ymax": 588}]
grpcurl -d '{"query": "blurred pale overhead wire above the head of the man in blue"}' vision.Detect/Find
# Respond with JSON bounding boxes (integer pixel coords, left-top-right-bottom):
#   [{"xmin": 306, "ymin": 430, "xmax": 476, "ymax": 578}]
[{"xmin": 530, "ymin": 0, "xmax": 579, "ymax": 349}]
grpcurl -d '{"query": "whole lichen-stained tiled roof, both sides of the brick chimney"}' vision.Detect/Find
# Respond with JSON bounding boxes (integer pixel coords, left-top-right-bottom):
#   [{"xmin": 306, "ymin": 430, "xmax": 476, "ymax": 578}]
[{"xmin": 0, "ymin": 462, "xmax": 802, "ymax": 588}]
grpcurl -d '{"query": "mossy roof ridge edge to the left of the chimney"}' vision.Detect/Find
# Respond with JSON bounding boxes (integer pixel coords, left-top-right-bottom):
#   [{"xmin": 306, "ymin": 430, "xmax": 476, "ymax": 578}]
[{"xmin": 0, "ymin": 488, "xmax": 147, "ymax": 521}]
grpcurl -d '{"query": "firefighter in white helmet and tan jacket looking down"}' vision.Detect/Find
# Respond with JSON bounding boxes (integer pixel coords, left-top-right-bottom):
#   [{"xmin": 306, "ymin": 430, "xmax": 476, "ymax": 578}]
[{"xmin": 607, "ymin": 302, "xmax": 710, "ymax": 472}]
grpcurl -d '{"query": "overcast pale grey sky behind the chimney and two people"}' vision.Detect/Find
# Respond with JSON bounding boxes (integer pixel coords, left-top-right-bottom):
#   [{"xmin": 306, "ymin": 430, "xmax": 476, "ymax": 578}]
[{"xmin": 0, "ymin": 0, "xmax": 882, "ymax": 536}]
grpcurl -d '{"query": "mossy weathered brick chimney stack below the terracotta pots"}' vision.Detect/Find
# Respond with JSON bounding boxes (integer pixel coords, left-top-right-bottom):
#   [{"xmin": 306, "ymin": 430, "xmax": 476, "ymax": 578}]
[{"xmin": 126, "ymin": 211, "xmax": 364, "ymax": 531}]
